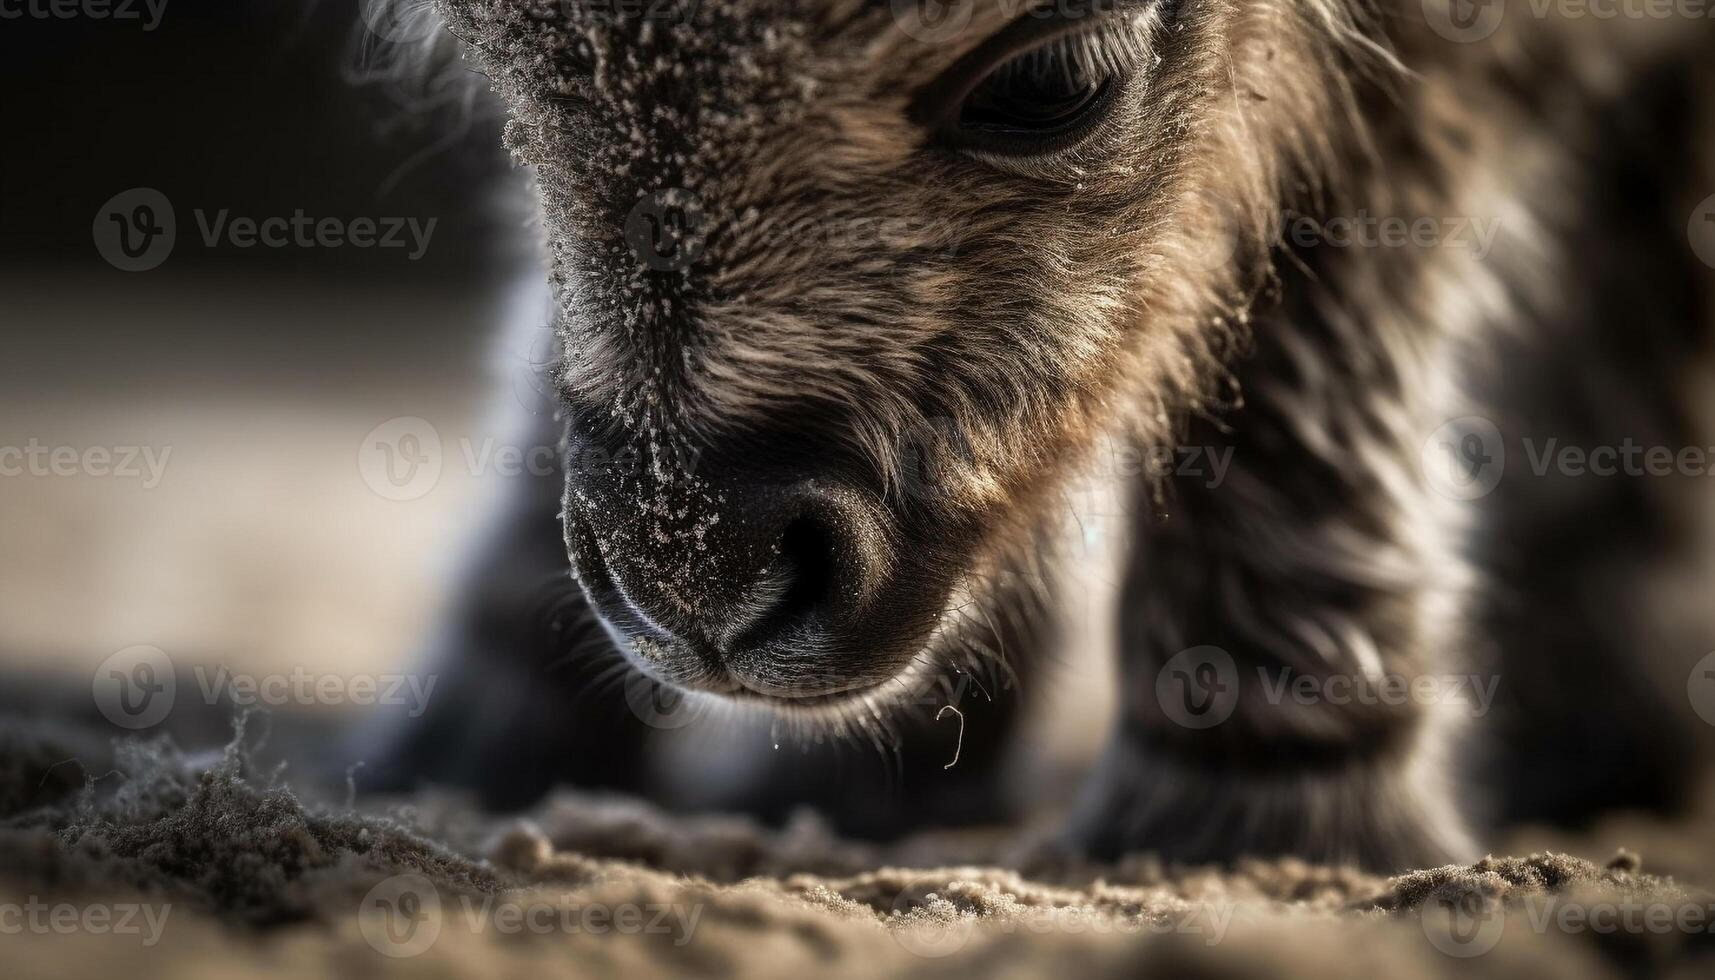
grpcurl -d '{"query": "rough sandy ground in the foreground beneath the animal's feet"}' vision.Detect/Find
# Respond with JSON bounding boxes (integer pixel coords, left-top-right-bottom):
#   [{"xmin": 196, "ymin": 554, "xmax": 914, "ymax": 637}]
[{"xmin": 0, "ymin": 724, "xmax": 1715, "ymax": 978}]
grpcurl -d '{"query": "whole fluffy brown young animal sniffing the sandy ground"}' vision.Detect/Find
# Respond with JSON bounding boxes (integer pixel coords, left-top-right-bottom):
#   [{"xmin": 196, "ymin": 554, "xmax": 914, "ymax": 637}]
[{"xmin": 361, "ymin": 0, "xmax": 1715, "ymax": 870}]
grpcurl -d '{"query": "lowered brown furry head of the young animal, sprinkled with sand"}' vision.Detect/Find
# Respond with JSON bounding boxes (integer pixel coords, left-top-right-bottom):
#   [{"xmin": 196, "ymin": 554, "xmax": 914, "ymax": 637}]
[{"xmin": 421, "ymin": 0, "xmax": 1385, "ymax": 705}]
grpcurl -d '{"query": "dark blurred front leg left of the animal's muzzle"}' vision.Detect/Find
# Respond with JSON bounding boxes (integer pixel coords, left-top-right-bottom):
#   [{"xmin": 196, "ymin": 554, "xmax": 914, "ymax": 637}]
[{"xmin": 350, "ymin": 405, "xmax": 650, "ymax": 808}]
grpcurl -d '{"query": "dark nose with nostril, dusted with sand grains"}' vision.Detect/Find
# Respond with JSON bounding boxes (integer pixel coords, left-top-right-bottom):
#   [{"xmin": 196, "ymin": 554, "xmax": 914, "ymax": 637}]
[{"xmin": 566, "ymin": 446, "xmax": 878, "ymax": 666}]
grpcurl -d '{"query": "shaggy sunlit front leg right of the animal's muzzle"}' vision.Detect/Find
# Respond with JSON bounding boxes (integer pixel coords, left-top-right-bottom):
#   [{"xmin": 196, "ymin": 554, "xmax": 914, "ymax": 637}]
[{"xmin": 1072, "ymin": 284, "xmax": 1480, "ymax": 870}]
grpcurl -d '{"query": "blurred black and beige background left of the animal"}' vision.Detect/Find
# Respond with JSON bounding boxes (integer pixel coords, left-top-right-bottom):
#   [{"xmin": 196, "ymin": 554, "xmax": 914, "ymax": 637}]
[{"xmin": 0, "ymin": 0, "xmax": 535, "ymax": 689}]
